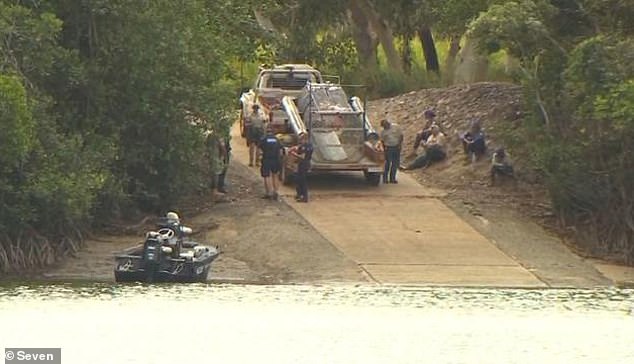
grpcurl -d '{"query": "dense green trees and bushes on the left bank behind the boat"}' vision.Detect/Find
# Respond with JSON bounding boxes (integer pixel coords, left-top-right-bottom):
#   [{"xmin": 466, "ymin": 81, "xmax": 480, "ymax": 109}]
[{"xmin": 0, "ymin": 0, "xmax": 252, "ymax": 245}]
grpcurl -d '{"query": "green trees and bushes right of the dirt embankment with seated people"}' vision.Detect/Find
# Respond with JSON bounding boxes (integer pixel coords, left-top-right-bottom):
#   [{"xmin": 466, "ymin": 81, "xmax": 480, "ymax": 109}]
[{"xmin": 470, "ymin": 0, "xmax": 634, "ymax": 262}]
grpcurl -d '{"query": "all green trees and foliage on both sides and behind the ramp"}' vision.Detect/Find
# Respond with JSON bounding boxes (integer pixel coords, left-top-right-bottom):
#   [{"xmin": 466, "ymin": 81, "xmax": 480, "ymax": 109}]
[{"xmin": 0, "ymin": 0, "xmax": 634, "ymax": 270}]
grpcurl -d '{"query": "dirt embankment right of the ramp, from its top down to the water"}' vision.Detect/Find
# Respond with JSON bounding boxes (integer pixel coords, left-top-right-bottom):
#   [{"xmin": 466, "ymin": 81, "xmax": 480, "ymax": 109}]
[{"xmin": 360, "ymin": 82, "xmax": 634, "ymax": 286}]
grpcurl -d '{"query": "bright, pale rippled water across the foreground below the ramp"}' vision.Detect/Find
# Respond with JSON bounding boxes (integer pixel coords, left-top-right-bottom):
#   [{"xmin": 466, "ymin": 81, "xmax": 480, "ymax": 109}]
[{"xmin": 0, "ymin": 284, "xmax": 634, "ymax": 364}]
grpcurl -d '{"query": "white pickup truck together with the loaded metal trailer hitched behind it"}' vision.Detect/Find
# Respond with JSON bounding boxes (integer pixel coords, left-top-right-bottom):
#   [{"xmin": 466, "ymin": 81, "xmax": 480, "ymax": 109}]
[{"xmin": 240, "ymin": 64, "xmax": 384, "ymax": 185}]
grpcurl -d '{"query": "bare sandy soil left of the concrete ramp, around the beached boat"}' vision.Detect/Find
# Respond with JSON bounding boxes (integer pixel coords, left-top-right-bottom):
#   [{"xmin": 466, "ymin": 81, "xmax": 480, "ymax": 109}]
[{"xmin": 44, "ymin": 162, "xmax": 366, "ymax": 283}]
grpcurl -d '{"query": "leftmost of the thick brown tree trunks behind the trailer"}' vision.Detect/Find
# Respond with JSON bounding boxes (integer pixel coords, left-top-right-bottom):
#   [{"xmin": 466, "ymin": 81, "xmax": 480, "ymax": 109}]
[{"xmin": 348, "ymin": 1, "xmax": 378, "ymax": 73}]
